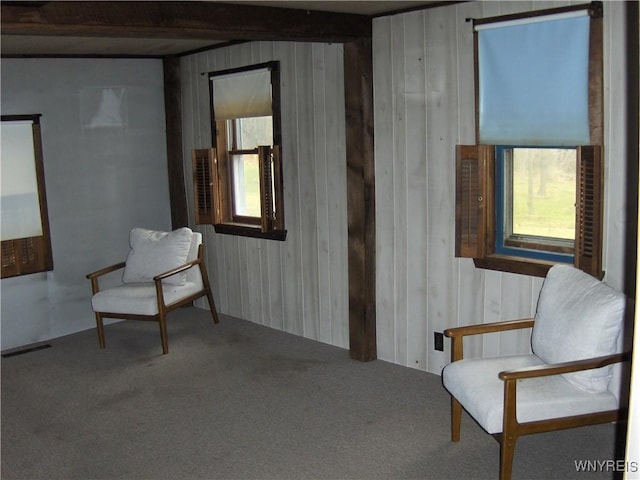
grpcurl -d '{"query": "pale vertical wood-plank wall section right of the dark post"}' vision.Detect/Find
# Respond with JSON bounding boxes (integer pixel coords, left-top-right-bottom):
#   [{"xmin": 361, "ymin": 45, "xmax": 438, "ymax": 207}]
[{"xmin": 373, "ymin": 1, "xmax": 625, "ymax": 374}]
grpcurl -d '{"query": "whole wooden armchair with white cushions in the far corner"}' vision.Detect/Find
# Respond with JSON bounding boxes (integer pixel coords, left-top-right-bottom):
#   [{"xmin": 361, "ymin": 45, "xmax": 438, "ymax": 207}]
[{"xmin": 87, "ymin": 228, "xmax": 219, "ymax": 354}]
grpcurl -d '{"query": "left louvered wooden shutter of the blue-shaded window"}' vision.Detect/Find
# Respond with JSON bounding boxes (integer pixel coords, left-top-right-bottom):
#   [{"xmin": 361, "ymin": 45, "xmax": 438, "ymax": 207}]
[{"xmin": 455, "ymin": 145, "xmax": 494, "ymax": 258}]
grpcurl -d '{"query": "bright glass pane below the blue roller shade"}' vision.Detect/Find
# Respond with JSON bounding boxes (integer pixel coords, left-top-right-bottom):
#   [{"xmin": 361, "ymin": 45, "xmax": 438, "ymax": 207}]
[{"xmin": 512, "ymin": 148, "xmax": 576, "ymax": 240}]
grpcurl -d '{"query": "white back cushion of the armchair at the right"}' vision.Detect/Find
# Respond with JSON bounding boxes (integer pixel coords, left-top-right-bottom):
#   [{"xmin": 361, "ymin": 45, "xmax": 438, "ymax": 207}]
[{"xmin": 531, "ymin": 265, "xmax": 625, "ymax": 393}]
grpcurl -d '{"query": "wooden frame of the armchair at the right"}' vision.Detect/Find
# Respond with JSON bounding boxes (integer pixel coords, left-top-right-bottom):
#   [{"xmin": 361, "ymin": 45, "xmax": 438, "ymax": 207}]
[{"xmin": 444, "ymin": 318, "xmax": 630, "ymax": 480}]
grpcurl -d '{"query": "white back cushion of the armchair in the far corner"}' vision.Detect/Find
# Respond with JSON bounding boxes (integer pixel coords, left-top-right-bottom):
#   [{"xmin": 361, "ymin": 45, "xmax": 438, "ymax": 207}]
[{"xmin": 122, "ymin": 227, "xmax": 193, "ymax": 285}]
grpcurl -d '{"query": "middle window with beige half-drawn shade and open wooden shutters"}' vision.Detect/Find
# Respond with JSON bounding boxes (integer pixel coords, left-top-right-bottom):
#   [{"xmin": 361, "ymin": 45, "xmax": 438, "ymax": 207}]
[{"xmin": 192, "ymin": 62, "xmax": 286, "ymax": 240}]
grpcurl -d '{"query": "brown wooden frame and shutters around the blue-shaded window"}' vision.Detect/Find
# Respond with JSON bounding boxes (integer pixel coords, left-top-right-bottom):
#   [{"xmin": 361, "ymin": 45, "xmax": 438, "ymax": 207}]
[{"xmin": 455, "ymin": 2, "xmax": 604, "ymax": 278}]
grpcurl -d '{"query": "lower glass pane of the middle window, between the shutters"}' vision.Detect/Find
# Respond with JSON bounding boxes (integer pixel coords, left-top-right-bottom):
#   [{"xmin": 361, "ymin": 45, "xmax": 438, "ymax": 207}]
[{"xmin": 232, "ymin": 154, "xmax": 261, "ymax": 218}]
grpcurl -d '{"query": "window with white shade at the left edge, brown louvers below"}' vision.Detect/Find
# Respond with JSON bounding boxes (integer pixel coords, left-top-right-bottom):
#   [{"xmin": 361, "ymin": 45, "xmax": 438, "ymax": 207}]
[{"xmin": 0, "ymin": 115, "xmax": 53, "ymax": 278}]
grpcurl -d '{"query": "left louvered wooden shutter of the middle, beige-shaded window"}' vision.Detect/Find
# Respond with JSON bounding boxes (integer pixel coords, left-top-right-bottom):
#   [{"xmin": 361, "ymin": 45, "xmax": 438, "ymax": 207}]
[{"xmin": 191, "ymin": 148, "xmax": 215, "ymax": 225}]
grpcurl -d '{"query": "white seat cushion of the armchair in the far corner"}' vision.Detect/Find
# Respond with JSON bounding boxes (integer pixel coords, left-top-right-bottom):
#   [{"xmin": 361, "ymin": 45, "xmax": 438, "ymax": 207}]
[{"xmin": 91, "ymin": 282, "xmax": 202, "ymax": 315}]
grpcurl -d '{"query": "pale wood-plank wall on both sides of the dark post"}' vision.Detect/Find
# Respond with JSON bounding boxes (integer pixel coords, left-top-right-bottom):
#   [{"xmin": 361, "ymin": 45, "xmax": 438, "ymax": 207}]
[{"xmin": 181, "ymin": 1, "xmax": 626, "ymax": 374}]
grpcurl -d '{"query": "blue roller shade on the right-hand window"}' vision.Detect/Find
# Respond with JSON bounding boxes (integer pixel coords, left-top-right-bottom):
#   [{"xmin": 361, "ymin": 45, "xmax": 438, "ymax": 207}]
[{"xmin": 476, "ymin": 11, "xmax": 590, "ymax": 146}]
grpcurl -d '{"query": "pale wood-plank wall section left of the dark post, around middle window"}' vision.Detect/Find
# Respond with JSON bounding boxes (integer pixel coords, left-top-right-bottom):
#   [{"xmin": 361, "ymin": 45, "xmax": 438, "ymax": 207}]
[{"xmin": 181, "ymin": 42, "xmax": 349, "ymax": 348}]
